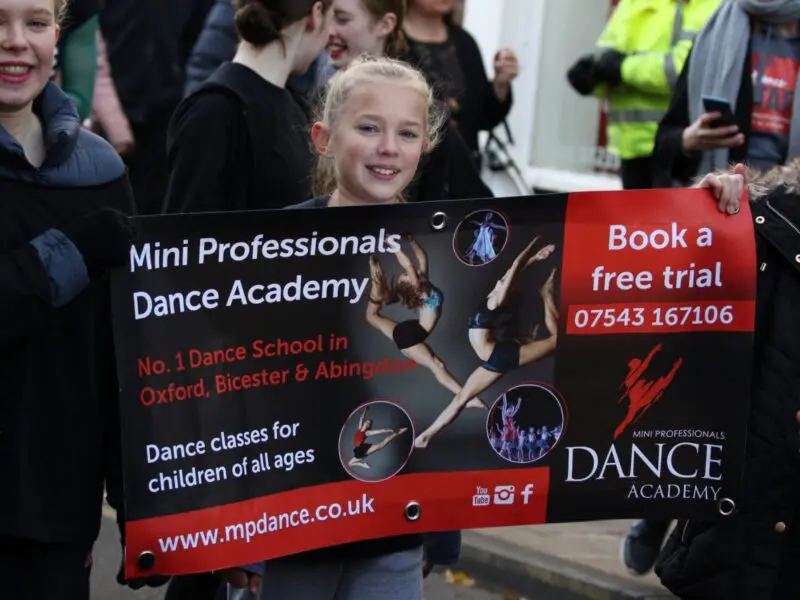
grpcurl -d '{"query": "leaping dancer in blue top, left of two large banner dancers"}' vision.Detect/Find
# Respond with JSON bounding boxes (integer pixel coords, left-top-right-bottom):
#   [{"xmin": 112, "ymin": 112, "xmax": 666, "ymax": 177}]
[{"xmin": 366, "ymin": 234, "xmax": 488, "ymax": 409}]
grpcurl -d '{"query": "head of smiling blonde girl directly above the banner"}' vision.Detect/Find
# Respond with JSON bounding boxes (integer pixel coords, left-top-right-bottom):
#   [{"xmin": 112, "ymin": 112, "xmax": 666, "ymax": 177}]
[{"xmin": 304, "ymin": 57, "xmax": 445, "ymax": 207}]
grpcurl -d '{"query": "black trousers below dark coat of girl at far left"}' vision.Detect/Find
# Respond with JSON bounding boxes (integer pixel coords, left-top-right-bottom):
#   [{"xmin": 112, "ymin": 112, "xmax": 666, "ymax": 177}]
[{"xmin": 0, "ymin": 536, "xmax": 92, "ymax": 600}]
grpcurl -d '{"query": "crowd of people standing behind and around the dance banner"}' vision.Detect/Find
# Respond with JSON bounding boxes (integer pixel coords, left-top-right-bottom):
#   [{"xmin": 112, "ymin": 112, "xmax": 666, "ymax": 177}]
[{"xmin": 0, "ymin": 0, "xmax": 800, "ymax": 600}]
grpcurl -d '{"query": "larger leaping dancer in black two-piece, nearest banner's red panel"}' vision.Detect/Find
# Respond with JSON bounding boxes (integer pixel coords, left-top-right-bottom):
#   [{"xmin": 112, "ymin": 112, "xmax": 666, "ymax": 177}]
[{"xmin": 414, "ymin": 236, "xmax": 558, "ymax": 448}]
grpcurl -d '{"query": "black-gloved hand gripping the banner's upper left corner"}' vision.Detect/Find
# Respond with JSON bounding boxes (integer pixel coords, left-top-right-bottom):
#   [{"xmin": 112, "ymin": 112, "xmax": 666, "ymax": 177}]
[{"xmin": 61, "ymin": 208, "xmax": 136, "ymax": 273}]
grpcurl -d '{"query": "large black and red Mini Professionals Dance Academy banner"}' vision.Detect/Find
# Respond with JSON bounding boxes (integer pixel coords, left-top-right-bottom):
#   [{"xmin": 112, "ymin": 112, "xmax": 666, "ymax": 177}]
[{"xmin": 112, "ymin": 190, "xmax": 756, "ymax": 577}]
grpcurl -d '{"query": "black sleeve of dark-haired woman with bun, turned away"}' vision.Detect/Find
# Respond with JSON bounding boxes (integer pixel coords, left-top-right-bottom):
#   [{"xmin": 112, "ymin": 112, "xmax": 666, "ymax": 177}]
[{"xmin": 165, "ymin": 91, "xmax": 248, "ymax": 213}]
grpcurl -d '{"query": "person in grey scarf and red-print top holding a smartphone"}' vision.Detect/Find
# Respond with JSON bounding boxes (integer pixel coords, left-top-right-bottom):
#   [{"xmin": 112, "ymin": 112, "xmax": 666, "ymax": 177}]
[{"xmin": 654, "ymin": 0, "xmax": 800, "ymax": 187}]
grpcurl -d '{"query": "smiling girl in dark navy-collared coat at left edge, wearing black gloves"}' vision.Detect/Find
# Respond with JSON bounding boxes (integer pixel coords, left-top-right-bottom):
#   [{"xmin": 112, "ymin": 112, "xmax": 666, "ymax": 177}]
[{"xmin": 0, "ymin": 0, "xmax": 133, "ymax": 600}]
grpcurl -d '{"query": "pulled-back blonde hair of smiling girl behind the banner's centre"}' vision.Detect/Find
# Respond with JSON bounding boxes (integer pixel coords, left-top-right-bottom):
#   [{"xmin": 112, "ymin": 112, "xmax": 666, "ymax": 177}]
[{"xmin": 313, "ymin": 56, "xmax": 447, "ymax": 201}]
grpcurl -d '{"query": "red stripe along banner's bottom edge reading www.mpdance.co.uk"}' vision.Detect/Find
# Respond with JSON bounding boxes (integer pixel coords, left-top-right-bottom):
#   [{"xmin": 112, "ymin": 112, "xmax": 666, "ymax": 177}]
[{"xmin": 125, "ymin": 467, "xmax": 550, "ymax": 578}]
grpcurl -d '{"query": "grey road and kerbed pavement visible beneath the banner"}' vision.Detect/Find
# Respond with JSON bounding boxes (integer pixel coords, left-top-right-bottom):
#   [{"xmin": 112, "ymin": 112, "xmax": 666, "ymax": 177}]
[{"xmin": 92, "ymin": 507, "xmax": 675, "ymax": 600}]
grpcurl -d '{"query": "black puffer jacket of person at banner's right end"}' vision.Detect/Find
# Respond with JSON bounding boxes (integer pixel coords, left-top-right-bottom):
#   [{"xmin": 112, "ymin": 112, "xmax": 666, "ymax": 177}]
[{"xmin": 656, "ymin": 190, "xmax": 800, "ymax": 600}]
